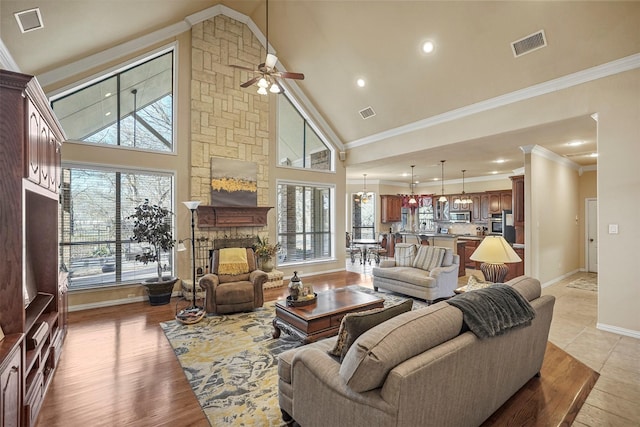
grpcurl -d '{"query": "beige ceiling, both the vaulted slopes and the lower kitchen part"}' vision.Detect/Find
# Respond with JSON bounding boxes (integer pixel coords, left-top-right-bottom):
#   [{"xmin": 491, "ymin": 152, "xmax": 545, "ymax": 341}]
[{"xmin": 0, "ymin": 0, "xmax": 640, "ymax": 186}]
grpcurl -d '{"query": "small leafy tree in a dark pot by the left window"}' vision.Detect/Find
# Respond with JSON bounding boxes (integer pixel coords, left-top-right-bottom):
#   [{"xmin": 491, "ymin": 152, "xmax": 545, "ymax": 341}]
[{"xmin": 127, "ymin": 199, "xmax": 178, "ymax": 305}]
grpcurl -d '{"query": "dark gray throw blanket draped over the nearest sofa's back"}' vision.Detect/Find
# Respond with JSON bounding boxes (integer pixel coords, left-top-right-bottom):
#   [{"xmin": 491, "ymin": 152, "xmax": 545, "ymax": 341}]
[{"xmin": 447, "ymin": 284, "xmax": 536, "ymax": 339}]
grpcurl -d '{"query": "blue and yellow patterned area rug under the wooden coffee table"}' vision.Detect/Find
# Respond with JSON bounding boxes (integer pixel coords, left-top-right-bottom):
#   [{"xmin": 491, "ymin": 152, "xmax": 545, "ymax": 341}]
[{"xmin": 160, "ymin": 286, "xmax": 427, "ymax": 426}]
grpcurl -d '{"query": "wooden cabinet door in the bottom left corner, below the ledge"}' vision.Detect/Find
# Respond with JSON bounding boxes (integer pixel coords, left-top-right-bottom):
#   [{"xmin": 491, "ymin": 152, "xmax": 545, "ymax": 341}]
[{"xmin": 0, "ymin": 346, "xmax": 22, "ymax": 427}]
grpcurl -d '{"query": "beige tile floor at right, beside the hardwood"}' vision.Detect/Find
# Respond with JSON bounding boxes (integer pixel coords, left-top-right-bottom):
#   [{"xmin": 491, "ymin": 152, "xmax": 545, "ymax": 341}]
[{"xmin": 346, "ymin": 260, "xmax": 640, "ymax": 427}]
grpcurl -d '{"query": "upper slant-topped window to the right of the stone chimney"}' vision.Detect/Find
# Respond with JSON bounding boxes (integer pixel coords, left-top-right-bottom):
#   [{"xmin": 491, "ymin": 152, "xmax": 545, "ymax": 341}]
[{"xmin": 278, "ymin": 96, "xmax": 331, "ymax": 170}]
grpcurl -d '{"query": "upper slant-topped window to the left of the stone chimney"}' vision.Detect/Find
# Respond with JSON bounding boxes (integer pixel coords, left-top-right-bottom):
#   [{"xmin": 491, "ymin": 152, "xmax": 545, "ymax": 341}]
[{"xmin": 51, "ymin": 51, "xmax": 174, "ymax": 152}]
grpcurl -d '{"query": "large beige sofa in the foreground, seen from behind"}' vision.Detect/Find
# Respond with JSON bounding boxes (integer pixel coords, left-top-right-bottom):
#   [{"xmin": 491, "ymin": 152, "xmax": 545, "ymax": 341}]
[{"xmin": 278, "ymin": 276, "xmax": 555, "ymax": 427}]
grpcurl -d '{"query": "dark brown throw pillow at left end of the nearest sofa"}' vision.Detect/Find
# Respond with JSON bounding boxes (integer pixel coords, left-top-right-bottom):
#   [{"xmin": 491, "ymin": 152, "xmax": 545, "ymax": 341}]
[{"xmin": 328, "ymin": 299, "xmax": 413, "ymax": 362}]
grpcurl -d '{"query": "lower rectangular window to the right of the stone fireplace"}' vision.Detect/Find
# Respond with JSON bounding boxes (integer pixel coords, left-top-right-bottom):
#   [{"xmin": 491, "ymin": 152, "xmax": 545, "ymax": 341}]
[{"xmin": 277, "ymin": 183, "xmax": 333, "ymax": 265}]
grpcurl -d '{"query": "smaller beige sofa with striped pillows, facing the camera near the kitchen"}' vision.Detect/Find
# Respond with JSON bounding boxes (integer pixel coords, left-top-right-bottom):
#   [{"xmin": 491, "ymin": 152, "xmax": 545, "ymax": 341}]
[{"xmin": 372, "ymin": 243, "xmax": 460, "ymax": 302}]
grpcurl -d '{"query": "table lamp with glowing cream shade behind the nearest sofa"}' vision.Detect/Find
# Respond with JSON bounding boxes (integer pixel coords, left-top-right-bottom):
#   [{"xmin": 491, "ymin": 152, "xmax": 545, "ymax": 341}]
[{"xmin": 469, "ymin": 236, "xmax": 522, "ymax": 283}]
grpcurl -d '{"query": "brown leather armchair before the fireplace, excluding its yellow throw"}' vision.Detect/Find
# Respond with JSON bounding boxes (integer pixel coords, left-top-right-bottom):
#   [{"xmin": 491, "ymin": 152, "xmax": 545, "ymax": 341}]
[{"xmin": 200, "ymin": 248, "xmax": 267, "ymax": 314}]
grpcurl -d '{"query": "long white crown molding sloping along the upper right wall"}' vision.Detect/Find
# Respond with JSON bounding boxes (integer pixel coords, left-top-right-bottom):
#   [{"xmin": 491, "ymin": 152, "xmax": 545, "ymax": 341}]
[{"xmin": 345, "ymin": 53, "xmax": 640, "ymax": 148}]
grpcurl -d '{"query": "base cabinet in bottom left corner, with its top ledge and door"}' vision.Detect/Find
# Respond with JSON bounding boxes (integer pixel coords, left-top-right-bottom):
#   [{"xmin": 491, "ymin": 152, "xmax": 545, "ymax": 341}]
[{"xmin": 0, "ymin": 334, "xmax": 22, "ymax": 427}]
